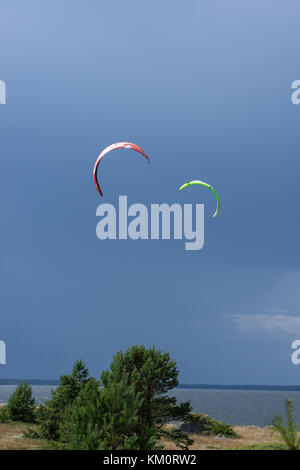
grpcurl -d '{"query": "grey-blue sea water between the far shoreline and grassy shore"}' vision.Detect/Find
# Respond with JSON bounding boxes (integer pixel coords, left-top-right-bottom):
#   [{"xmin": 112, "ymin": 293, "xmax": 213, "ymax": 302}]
[{"xmin": 0, "ymin": 385, "xmax": 300, "ymax": 426}]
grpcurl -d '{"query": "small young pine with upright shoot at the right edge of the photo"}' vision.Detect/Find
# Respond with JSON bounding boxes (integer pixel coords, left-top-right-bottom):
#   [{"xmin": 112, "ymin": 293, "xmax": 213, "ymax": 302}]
[{"xmin": 273, "ymin": 400, "xmax": 300, "ymax": 450}]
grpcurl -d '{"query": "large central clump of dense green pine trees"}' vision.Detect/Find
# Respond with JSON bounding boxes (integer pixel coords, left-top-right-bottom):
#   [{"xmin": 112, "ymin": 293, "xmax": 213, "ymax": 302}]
[{"xmin": 32, "ymin": 346, "xmax": 192, "ymax": 450}]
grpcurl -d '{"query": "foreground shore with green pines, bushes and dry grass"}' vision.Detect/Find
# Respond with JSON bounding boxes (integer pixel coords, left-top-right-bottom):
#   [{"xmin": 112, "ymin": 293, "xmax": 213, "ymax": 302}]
[{"xmin": 0, "ymin": 345, "xmax": 300, "ymax": 450}]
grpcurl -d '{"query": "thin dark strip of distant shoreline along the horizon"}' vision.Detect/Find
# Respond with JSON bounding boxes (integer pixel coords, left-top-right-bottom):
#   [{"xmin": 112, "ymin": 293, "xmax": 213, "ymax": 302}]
[{"xmin": 0, "ymin": 379, "xmax": 300, "ymax": 392}]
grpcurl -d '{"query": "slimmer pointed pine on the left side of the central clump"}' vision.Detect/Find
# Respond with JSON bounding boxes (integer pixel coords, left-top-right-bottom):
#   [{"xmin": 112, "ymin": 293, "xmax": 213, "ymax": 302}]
[{"xmin": 36, "ymin": 360, "xmax": 90, "ymax": 441}]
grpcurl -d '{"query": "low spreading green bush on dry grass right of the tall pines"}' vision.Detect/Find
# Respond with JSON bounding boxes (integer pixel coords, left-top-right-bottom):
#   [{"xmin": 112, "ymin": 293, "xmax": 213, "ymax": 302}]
[{"xmin": 185, "ymin": 413, "xmax": 239, "ymax": 439}]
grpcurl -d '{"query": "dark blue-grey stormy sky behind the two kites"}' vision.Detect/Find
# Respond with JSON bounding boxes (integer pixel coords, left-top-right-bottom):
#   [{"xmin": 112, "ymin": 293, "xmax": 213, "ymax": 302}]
[{"xmin": 0, "ymin": 0, "xmax": 300, "ymax": 384}]
